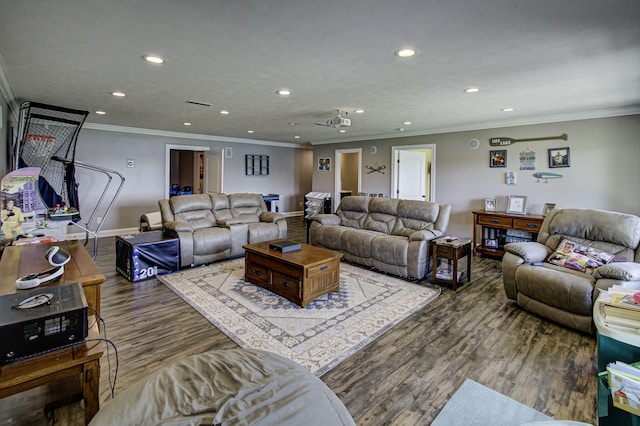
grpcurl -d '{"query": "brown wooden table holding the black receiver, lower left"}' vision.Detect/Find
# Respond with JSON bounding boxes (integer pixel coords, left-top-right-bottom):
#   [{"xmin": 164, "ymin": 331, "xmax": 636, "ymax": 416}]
[{"xmin": 0, "ymin": 322, "xmax": 103, "ymax": 424}]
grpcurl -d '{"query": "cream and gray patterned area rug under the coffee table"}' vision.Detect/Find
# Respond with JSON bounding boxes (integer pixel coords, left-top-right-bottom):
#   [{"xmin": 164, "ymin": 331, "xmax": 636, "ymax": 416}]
[{"xmin": 158, "ymin": 259, "xmax": 440, "ymax": 376}]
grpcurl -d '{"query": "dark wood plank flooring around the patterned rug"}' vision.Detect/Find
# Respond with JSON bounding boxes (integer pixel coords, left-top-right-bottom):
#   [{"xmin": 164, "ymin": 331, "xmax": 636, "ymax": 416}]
[{"xmin": 0, "ymin": 217, "xmax": 597, "ymax": 425}]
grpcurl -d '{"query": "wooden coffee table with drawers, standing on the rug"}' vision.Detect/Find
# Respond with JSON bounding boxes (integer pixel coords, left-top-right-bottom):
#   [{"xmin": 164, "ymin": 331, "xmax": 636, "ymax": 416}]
[{"xmin": 243, "ymin": 240, "xmax": 342, "ymax": 308}]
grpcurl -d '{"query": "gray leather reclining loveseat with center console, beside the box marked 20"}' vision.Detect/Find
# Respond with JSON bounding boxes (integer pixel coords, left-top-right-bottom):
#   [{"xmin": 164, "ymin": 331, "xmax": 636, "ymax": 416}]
[{"xmin": 158, "ymin": 193, "xmax": 287, "ymax": 267}]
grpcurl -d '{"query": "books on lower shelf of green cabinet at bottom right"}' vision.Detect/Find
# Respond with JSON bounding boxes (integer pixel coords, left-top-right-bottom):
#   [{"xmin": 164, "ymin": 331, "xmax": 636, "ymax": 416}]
[{"xmin": 607, "ymin": 361, "xmax": 640, "ymax": 416}]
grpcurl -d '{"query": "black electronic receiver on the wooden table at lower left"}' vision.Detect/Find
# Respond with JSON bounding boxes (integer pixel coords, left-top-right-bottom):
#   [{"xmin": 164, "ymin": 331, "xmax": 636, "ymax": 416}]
[{"xmin": 0, "ymin": 283, "xmax": 89, "ymax": 364}]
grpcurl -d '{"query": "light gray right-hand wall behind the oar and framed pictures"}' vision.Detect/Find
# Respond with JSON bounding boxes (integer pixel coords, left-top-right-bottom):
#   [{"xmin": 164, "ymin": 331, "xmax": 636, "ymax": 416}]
[{"xmin": 313, "ymin": 115, "xmax": 640, "ymax": 237}]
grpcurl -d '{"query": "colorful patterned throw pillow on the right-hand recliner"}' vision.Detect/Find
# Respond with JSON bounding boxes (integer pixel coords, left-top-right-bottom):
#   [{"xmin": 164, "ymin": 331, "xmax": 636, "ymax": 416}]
[{"xmin": 547, "ymin": 238, "xmax": 615, "ymax": 274}]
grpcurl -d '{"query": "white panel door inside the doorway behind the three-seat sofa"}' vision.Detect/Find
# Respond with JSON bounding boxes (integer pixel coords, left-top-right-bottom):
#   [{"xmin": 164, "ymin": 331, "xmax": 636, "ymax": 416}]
[{"xmin": 398, "ymin": 151, "xmax": 429, "ymax": 201}]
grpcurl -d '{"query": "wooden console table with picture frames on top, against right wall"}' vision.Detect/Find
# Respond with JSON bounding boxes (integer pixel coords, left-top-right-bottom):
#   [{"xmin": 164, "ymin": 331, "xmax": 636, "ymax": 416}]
[{"xmin": 473, "ymin": 210, "xmax": 544, "ymax": 257}]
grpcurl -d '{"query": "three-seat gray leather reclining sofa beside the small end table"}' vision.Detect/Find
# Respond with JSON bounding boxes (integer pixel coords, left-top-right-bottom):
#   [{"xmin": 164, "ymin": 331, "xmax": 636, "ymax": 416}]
[{"xmin": 309, "ymin": 196, "xmax": 451, "ymax": 279}]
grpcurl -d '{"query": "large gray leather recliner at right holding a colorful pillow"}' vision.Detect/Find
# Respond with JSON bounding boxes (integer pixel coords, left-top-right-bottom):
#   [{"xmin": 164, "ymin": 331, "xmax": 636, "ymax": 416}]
[{"xmin": 502, "ymin": 209, "xmax": 640, "ymax": 334}]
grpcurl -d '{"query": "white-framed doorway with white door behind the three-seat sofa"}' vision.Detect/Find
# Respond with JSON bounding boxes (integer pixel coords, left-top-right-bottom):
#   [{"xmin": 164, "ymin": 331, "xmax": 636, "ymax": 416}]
[{"xmin": 391, "ymin": 144, "xmax": 436, "ymax": 202}]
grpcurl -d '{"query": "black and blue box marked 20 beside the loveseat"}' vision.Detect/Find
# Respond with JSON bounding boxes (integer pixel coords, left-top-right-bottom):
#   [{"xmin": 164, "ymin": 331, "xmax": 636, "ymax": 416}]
[{"xmin": 116, "ymin": 231, "xmax": 180, "ymax": 282}]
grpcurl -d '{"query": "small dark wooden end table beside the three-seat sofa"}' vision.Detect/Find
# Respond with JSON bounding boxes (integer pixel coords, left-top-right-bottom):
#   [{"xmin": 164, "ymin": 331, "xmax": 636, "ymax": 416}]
[{"xmin": 431, "ymin": 237, "xmax": 471, "ymax": 290}]
